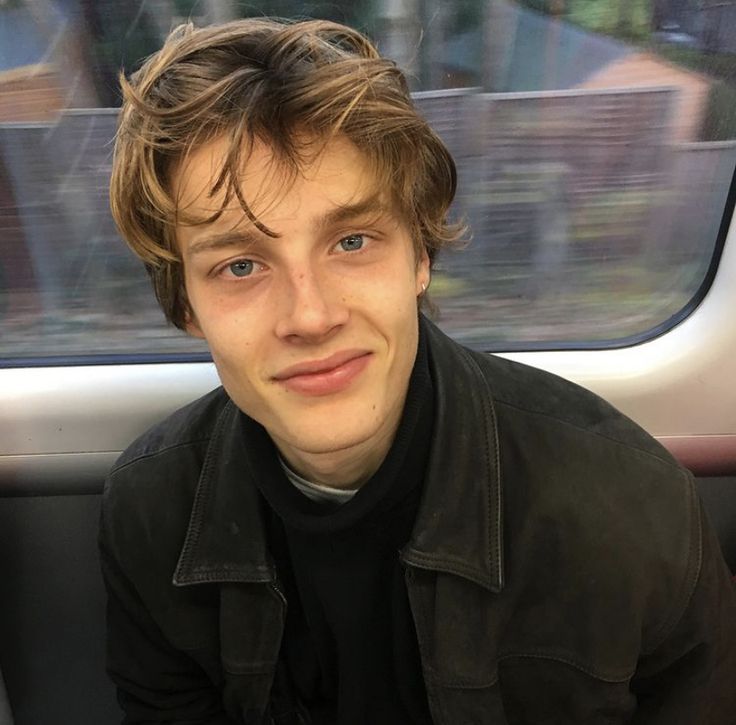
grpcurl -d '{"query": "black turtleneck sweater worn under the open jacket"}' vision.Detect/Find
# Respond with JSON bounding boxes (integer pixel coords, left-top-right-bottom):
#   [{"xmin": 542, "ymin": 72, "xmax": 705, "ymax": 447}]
[{"xmin": 242, "ymin": 337, "xmax": 434, "ymax": 725}]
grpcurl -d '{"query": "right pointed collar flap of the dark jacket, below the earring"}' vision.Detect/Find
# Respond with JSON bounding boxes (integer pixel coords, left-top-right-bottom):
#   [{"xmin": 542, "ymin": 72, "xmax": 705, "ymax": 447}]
[{"xmin": 402, "ymin": 317, "xmax": 504, "ymax": 592}]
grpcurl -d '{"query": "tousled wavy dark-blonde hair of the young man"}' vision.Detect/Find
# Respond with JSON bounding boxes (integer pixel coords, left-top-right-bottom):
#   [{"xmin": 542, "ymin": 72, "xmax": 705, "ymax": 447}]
[{"xmin": 110, "ymin": 19, "xmax": 463, "ymax": 329}]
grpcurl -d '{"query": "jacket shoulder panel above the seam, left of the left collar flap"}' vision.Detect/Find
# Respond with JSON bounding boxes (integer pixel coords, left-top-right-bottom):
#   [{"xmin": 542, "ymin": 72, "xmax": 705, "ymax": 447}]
[{"xmin": 111, "ymin": 387, "xmax": 230, "ymax": 474}]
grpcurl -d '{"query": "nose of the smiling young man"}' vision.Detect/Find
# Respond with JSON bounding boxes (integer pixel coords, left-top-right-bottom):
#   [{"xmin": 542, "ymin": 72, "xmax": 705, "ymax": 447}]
[{"xmin": 276, "ymin": 264, "xmax": 349, "ymax": 343}]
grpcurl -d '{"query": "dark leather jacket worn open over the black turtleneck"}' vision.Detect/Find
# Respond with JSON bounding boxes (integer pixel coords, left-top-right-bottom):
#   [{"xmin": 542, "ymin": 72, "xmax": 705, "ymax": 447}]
[{"xmin": 100, "ymin": 320, "xmax": 736, "ymax": 725}]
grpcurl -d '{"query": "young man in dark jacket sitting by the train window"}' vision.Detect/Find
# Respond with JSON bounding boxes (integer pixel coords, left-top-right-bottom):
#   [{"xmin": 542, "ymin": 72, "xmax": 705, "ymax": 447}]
[{"xmin": 100, "ymin": 15, "xmax": 736, "ymax": 725}]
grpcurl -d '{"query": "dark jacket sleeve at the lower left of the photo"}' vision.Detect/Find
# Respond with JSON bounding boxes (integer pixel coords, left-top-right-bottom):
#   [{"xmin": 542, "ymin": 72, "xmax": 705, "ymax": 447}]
[{"xmin": 99, "ymin": 506, "xmax": 234, "ymax": 725}]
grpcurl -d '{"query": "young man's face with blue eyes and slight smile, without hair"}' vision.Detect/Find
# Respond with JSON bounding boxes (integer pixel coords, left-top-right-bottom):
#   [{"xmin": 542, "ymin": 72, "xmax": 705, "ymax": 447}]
[{"xmin": 173, "ymin": 137, "xmax": 429, "ymax": 478}]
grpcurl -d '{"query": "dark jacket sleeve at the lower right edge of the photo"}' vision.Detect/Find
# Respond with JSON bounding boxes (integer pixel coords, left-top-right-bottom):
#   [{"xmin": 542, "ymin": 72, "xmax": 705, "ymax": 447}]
[{"xmin": 631, "ymin": 504, "xmax": 736, "ymax": 725}]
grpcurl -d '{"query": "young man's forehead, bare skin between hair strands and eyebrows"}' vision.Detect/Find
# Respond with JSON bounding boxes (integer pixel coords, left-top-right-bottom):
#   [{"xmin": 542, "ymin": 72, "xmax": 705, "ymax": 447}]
[{"xmin": 171, "ymin": 137, "xmax": 385, "ymax": 224}]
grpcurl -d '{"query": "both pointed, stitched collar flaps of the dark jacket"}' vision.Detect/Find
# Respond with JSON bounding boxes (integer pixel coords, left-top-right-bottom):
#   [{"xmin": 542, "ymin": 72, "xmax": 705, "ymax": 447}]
[{"xmin": 173, "ymin": 317, "xmax": 503, "ymax": 591}]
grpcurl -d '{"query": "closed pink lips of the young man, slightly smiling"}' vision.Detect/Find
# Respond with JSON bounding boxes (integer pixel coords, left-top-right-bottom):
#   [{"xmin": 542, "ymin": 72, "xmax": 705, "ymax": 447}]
[{"xmin": 273, "ymin": 350, "xmax": 372, "ymax": 395}]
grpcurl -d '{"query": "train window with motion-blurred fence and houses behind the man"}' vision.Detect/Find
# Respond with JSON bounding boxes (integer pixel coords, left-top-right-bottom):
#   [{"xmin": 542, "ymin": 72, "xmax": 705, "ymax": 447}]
[{"xmin": 0, "ymin": 0, "xmax": 736, "ymax": 365}]
